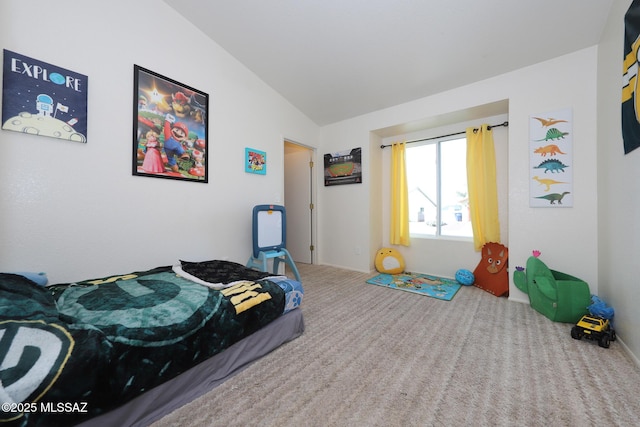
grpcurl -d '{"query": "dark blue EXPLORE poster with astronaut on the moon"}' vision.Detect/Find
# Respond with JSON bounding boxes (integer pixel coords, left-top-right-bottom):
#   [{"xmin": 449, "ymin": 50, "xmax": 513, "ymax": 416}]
[{"xmin": 2, "ymin": 49, "xmax": 89, "ymax": 143}]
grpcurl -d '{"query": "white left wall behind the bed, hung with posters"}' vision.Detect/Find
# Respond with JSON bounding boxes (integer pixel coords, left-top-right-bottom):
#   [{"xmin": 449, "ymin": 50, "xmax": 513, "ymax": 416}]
[{"xmin": 0, "ymin": 0, "xmax": 319, "ymax": 282}]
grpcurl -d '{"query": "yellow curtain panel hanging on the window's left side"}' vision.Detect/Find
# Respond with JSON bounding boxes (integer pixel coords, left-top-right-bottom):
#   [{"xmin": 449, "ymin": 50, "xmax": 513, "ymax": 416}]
[{"xmin": 390, "ymin": 142, "xmax": 409, "ymax": 246}]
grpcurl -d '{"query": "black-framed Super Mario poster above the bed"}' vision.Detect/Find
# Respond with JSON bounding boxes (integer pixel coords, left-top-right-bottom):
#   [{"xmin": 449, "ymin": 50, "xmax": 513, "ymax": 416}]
[{"xmin": 133, "ymin": 65, "xmax": 209, "ymax": 183}]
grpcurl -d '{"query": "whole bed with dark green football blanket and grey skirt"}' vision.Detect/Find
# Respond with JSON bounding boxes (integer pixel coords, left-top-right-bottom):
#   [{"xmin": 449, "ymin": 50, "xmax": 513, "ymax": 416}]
[{"xmin": 0, "ymin": 260, "xmax": 304, "ymax": 426}]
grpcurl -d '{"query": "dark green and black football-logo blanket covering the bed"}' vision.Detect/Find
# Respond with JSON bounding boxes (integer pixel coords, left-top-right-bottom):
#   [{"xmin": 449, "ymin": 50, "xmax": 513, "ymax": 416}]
[{"xmin": 0, "ymin": 267, "xmax": 285, "ymax": 426}]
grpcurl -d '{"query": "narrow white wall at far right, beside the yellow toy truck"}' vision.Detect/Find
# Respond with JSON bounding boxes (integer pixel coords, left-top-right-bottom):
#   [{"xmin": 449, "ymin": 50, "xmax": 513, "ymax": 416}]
[{"xmin": 598, "ymin": 0, "xmax": 640, "ymax": 364}]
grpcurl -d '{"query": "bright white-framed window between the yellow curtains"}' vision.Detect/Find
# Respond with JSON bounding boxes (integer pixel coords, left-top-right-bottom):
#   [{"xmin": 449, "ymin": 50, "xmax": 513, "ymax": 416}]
[{"xmin": 406, "ymin": 138, "xmax": 473, "ymax": 238}]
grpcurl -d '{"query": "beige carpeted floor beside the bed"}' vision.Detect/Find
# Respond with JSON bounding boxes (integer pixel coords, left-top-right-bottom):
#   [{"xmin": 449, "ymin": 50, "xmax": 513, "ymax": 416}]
[{"xmin": 153, "ymin": 265, "xmax": 640, "ymax": 427}]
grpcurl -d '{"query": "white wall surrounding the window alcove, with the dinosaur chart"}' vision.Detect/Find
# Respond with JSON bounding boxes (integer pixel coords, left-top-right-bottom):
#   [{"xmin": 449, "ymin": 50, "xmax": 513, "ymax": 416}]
[{"xmin": 318, "ymin": 46, "xmax": 598, "ymax": 302}]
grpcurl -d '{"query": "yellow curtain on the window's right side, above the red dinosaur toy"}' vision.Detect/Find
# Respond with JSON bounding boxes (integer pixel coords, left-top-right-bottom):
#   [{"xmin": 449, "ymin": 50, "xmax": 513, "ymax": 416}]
[{"xmin": 466, "ymin": 125, "xmax": 500, "ymax": 251}]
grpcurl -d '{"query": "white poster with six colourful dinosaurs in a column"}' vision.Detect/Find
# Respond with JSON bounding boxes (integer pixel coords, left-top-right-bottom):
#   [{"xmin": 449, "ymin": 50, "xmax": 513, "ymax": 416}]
[{"xmin": 529, "ymin": 108, "xmax": 573, "ymax": 208}]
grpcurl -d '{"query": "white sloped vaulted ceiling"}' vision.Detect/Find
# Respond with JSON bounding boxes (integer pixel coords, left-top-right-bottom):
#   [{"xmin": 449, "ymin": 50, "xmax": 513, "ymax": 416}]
[{"xmin": 164, "ymin": 0, "xmax": 622, "ymax": 126}]
